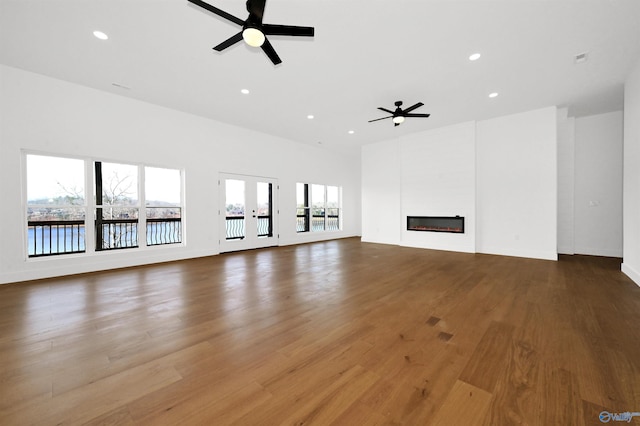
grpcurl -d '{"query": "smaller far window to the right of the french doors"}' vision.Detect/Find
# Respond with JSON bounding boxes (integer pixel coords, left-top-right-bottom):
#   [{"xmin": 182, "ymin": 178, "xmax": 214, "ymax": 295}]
[{"xmin": 296, "ymin": 183, "xmax": 341, "ymax": 232}]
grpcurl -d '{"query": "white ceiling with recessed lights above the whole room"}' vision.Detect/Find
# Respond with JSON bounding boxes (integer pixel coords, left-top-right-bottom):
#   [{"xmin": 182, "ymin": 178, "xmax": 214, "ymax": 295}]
[{"xmin": 0, "ymin": 0, "xmax": 640, "ymax": 155}]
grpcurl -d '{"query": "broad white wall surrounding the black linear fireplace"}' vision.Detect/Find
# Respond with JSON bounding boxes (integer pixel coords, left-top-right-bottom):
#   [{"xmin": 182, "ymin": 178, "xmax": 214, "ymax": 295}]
[{"xmin": 362, "ymin": 107, "xmax": 557, "ymax": 259}]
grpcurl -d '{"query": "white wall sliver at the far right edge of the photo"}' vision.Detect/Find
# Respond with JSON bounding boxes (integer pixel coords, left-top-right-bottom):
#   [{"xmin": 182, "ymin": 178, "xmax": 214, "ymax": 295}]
[{"xmin": 622, "ymin": 57, "xmax": 640, "ymax": 285}]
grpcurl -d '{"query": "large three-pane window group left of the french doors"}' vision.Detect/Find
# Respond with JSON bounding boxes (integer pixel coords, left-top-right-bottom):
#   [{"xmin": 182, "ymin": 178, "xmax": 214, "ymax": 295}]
[{"xmin": 25, "ymin": 154, "xmax": 182, "ymax": 257}]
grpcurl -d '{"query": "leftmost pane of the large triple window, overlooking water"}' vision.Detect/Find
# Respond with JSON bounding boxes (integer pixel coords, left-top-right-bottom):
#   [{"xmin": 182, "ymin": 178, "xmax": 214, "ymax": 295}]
[{"xmin": 26, "ymin": 155, "xmax": 86, "ymax": 257}]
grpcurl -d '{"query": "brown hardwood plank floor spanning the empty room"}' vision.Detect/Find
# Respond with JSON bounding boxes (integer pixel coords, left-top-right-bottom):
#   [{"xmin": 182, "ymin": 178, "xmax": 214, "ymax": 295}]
[{"xmin": 0, "ymin": 238, "xmax": 640, "ymax": 425}]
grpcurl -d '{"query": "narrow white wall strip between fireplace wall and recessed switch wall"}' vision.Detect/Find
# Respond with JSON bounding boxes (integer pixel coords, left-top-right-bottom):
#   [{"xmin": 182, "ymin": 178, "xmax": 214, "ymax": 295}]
[{"xmin": 558, "ymin": 108, "xmax": 576, "ymax": 254}]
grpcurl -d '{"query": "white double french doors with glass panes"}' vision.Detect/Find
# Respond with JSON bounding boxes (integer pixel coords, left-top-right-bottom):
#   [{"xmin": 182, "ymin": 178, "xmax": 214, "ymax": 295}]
[{"xmin": 218, "ymin": 173, "xmax": 278, "ymax": 252}]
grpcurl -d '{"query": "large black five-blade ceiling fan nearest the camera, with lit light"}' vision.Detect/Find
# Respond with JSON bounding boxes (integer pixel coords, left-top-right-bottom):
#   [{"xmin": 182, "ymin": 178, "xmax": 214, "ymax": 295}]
[{"xmin": 189, "ymin": 0, "xmax": 314, "ymax": 65}]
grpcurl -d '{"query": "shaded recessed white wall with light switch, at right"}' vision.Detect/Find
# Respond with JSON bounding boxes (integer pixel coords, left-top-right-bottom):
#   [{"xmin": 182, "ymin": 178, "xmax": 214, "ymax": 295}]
[{"xmin": 574, "ymin": 111, "xmax": 623, "ymax": 257}]
